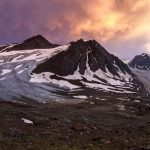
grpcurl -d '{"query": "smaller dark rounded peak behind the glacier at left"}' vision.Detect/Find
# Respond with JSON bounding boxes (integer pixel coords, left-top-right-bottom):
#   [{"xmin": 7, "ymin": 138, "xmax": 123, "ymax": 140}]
[{"xmin": 5, "ymin": 35, "xmax": 58, "ymax": 51}]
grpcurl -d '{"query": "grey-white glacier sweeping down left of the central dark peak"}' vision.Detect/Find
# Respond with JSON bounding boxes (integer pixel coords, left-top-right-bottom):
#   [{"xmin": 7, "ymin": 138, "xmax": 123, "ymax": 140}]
[{"xmin": 0, "ymin": 45, "xmax": 69, "ymax": 101}]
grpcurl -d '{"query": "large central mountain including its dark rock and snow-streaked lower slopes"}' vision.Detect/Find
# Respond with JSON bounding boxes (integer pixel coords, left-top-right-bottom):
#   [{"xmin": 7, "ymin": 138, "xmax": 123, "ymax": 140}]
[{"xmin": 31, "ymin": 39, "xmax": 143, "ymax": 96}]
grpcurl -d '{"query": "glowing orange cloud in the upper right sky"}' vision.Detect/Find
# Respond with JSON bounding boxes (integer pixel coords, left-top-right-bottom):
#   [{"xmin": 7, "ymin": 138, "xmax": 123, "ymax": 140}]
[{"xmin": 59, "ymin": 0, "xmax": 150, "ymax": 42}]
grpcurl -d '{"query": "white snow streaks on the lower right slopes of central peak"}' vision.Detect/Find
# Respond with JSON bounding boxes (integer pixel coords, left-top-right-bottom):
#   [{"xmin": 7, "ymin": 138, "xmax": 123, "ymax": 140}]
[{"xmin": 63, "ymin": 53, "xmax": 134, "ymax": 93}]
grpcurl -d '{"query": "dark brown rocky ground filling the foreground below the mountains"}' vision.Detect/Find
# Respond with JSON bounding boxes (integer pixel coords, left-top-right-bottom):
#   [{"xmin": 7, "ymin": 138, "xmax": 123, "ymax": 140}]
[{"xmin": 0, "ymin": 95, "xmax": 150, "ymax": 150}]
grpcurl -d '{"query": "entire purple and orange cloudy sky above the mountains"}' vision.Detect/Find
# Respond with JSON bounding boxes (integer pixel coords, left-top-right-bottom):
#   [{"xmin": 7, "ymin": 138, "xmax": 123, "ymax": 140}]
[{"xmin": 0, "ymin": 0, "xmax": 150, "ymax": 59}]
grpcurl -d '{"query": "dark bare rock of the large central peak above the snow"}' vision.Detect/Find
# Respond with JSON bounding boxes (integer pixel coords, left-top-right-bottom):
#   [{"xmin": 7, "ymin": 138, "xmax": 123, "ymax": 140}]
[{"xmin": 34, "ymin": 39, "xmax": 132, "ymax": 76}]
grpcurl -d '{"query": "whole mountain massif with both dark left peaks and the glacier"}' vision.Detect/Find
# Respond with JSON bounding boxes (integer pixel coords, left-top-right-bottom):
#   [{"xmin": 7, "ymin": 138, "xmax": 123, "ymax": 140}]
[{"xmin": 0, "ymin": 36, "xmax": 145, "ymax": 101}]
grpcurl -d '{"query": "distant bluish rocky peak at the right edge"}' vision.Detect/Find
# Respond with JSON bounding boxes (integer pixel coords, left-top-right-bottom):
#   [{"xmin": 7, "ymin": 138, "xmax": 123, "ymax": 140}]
[{"xmin": 129, "ymin": 53, "xmax": 150, "ymax": 70}]
